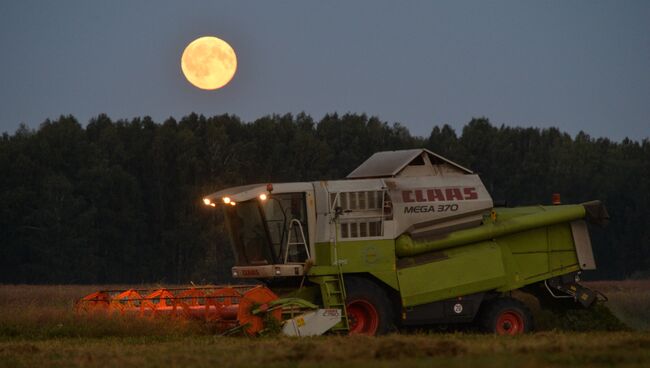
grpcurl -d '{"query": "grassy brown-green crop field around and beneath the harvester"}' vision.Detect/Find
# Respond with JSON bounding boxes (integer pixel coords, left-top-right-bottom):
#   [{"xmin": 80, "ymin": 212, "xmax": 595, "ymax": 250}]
[{"xmin": 0, "ymin": 281, "xmax": 650, "ymax": 368}]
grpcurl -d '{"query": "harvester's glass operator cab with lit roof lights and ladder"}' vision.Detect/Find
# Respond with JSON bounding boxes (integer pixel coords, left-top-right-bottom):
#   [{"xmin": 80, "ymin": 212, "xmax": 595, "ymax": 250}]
[{"xmin": 203, "ymin": 183, "xmax": 315, "ymax": 278}]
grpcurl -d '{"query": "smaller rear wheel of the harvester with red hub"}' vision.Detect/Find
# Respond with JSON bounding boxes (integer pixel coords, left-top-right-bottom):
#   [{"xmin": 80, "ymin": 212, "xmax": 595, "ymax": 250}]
[{"xmin": 478, "ymin": 297, "xmax": 534, "ymax": 336}]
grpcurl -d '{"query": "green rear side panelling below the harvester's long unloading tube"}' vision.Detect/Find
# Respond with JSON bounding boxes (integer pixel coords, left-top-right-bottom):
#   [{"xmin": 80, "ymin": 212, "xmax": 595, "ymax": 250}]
[{"xmin": 388, "ymin": 223, "xmax": 580, "ymax": 307}]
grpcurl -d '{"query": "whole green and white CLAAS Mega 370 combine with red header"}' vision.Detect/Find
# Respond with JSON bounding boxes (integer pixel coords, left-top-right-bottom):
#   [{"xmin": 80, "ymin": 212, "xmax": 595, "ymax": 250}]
[{"xmin": 77, "ymin": 149, "xmax": 608, "ymax": 336}]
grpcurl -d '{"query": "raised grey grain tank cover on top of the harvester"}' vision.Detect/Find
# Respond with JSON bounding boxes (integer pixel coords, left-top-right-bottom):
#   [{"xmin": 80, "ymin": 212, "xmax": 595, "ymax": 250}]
[{"xmin": 347, "ymin": 148, "xmax": 472, "ymax": 179}]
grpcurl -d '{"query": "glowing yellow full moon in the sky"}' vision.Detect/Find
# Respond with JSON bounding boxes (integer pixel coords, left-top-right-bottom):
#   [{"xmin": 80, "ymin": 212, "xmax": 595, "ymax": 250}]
[{"xmin": 181, "ymin": 36, "xmax": 237, "ymax": 90}]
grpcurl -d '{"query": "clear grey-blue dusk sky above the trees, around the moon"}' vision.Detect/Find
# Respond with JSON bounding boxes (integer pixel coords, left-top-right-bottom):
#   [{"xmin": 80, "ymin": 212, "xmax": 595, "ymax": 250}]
[{"xmin": 0, "ymin": 0, "xmax": 650, "ymax": 140}]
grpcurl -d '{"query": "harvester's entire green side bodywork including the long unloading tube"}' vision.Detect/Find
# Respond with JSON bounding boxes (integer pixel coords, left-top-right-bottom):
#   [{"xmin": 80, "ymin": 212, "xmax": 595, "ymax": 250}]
[{"xmin": 308, "ymin": 205, "xmax": 585, "ymax": 307}]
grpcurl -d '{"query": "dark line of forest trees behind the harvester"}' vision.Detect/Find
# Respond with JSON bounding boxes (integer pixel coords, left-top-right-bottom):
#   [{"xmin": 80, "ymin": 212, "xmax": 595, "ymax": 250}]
[{"xmin": 0, "ymin": 113, "xmax": 650, "ymax": 284}]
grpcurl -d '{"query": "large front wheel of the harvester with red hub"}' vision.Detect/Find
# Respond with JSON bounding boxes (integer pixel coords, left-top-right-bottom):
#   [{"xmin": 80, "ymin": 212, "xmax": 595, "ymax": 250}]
[{"xmin": 345, "ymin": 277, "xmax": 395, "ymax": 336}]
